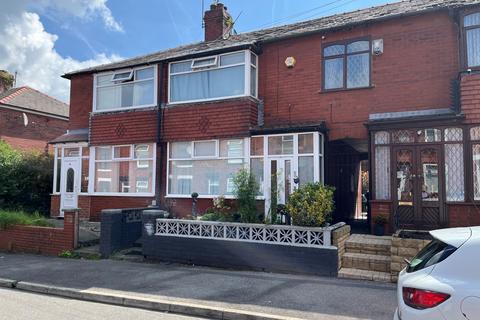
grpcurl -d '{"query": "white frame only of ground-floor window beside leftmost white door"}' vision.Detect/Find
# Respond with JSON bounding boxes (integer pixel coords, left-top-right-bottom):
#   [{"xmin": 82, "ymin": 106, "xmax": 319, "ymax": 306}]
[{"xmin": 88, "ymin": 142, "xmax": 157, "ymax": 197}]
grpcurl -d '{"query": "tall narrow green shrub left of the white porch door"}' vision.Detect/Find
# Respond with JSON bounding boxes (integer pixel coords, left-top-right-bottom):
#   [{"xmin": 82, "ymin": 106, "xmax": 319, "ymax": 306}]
[{"xmin": 233, "ymin": 169, "xmax": 260, "ymax": 223}]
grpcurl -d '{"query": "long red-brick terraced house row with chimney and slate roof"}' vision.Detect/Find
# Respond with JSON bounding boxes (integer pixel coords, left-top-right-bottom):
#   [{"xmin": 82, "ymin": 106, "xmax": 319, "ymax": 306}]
[{"xmin": 51, "ymin": 0, "xmax": 480, "ymax": 231}]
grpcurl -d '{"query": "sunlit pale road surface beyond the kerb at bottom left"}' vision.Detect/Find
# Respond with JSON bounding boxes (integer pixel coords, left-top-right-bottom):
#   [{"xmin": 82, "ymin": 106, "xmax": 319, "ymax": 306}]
[{"xmin": 0, "ymin": 289, "xmax": 204, "ymax": 320}]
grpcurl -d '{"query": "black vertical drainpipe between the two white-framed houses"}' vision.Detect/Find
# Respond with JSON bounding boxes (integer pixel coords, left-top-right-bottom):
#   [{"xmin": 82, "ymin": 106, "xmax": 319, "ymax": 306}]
[{"xmin": 155, "ymin": 62, "xmax": 167, "ymax": 207}]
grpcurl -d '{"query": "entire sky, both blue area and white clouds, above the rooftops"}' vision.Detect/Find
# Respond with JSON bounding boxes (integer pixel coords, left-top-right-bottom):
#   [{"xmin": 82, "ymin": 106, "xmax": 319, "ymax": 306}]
[{"xmin": 0, "ymin": 0, "xmax": 394, "ymax": 102}]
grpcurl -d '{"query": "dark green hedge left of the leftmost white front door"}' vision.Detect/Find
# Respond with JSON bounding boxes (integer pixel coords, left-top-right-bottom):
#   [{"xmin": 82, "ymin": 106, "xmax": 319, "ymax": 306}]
[{"xmin": 0, "ymin": 141, "xmax": 53, "ymax": 214}]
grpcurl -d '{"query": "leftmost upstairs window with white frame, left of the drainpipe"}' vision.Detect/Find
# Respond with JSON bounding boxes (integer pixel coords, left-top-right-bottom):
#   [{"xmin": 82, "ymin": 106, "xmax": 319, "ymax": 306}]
[{"xmin": 94, "ymin": 66, "xmax": 157, "ymax": 112}]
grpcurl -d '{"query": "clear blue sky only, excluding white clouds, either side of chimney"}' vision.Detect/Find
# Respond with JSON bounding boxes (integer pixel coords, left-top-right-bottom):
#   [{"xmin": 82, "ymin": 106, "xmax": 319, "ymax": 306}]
[{"xmin": 40, "ymin": 0, "xmax": 392, "ymax": 60}]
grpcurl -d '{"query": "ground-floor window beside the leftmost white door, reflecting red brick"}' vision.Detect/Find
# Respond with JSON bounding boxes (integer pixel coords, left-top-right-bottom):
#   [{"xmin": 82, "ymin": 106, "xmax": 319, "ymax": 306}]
[{"xmin": 94, "ymin": 144, "xmax": 155, "ymax": 194}]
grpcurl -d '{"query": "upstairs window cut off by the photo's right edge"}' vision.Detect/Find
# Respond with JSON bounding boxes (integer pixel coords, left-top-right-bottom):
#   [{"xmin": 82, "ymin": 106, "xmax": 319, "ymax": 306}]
[{"xmin": 463, "ymin": 12, "xmax": 480, "ymax": 68}]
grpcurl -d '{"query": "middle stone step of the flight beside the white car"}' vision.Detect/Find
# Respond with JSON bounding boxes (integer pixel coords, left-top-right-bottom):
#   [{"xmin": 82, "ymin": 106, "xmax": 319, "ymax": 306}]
[{"xmin": 342, "ymin": 252, "xmax": 391, "ymax": 272}]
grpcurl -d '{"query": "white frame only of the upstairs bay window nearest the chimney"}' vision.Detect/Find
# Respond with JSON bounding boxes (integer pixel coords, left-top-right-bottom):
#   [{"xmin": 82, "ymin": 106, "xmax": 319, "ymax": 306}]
[{"xmin": 167, "ymin": 50, "xmax": 258, "ymax": 105}]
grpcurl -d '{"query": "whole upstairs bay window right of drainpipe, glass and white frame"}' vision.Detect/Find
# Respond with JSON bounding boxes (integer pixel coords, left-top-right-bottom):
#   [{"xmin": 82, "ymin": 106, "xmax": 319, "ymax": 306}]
[{"xmin": 169, "ymin": 51, "xmax": 257, "ymax": 103}]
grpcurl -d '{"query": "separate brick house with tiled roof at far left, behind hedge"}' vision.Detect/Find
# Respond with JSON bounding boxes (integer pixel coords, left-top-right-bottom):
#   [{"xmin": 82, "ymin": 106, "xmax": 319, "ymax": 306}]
[{"xmin": 0, "ymin": 70, "xmax": 68, "ymax": 152}]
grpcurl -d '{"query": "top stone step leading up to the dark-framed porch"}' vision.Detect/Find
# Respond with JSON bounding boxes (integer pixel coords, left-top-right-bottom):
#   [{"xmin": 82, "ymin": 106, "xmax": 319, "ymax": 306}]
[{"xmin": 345, "ymin": 234, "xmax": 392, "ymax": 256}]
